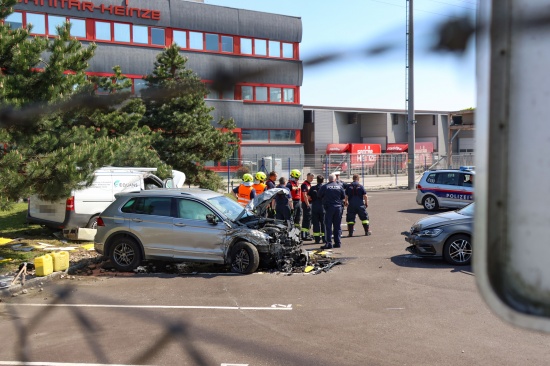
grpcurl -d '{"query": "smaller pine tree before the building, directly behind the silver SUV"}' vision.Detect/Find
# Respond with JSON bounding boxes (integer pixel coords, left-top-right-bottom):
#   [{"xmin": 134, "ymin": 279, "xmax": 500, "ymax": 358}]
[{"xmin": 142, "ymin": 44, "xmax": 237, "ymax": 190}]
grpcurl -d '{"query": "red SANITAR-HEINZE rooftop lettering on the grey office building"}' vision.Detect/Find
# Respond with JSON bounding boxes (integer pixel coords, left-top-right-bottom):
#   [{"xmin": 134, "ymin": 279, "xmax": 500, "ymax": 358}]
[{"xmin": 19, "ymin": 0, "xmax": 160, "ymax": 20}]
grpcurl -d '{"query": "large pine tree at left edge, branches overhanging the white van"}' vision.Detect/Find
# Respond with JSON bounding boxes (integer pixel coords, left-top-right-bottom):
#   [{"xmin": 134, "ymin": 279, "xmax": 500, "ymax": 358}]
[{"xmin": 0, "ymin": 0, "xmax": 166, "ymax": 209}]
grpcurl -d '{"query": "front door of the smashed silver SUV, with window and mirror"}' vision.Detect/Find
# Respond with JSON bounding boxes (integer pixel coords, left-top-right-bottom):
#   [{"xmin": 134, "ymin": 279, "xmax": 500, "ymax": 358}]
[{"xmin": 174, "ymin": 198, "xmax": 227, "ymax": 263}]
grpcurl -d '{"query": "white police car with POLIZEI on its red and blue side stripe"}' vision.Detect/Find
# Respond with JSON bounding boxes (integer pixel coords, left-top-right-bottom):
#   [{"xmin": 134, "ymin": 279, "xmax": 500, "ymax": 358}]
[{"xmin": 416, "ymin": 166, "xmax": 475, "ymax": 211}]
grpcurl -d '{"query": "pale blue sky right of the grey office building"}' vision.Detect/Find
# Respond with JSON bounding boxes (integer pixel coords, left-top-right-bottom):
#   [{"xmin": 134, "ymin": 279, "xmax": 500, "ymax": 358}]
[{"xmin": 204, "ymin": 0, "xmax": 476, "ymax": 111}]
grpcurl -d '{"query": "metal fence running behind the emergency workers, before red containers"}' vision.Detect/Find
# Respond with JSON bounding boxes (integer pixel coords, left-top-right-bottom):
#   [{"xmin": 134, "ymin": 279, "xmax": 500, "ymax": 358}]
[{"xmin": 211, "ymin": 153, "xmax": 474, "ymax": 185}]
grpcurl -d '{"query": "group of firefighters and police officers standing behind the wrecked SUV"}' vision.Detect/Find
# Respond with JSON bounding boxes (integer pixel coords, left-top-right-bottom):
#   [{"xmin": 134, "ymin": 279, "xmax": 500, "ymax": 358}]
[{"xmin": 233, "ymin": 169, "xmax": 371, "ymax": 249}]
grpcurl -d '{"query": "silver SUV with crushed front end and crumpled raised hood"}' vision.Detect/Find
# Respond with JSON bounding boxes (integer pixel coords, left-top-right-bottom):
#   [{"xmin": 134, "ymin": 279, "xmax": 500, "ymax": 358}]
[{"xmin": 94, "ymin": 188, "xmax": 305, "ymax": 273}]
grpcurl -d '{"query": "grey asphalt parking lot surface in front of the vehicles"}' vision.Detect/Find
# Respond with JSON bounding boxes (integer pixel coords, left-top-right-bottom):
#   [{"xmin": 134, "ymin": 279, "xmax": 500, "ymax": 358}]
[{"xmin": 0, "ymin": 190, "xmax": 550, "ymax": 366}]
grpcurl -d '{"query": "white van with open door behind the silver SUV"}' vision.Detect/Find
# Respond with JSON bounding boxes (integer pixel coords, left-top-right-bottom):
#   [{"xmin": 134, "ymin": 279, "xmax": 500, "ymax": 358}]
[{"xmin": 27, "ymin": 167, "xmax": 185, "ymax": 229}]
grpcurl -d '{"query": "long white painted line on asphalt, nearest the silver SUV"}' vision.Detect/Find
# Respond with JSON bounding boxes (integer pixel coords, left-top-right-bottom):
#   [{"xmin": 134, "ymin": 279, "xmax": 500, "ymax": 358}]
[{"xmin": 4, "ymin": 303, "xmax": 292, "ymax": 310}]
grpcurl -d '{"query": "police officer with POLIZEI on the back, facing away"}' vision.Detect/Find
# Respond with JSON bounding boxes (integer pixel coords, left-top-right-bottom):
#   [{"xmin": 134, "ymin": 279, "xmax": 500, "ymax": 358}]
[{"xmin": 319, "ymin": 174, "xmax": 346, "ymax": 249}]
